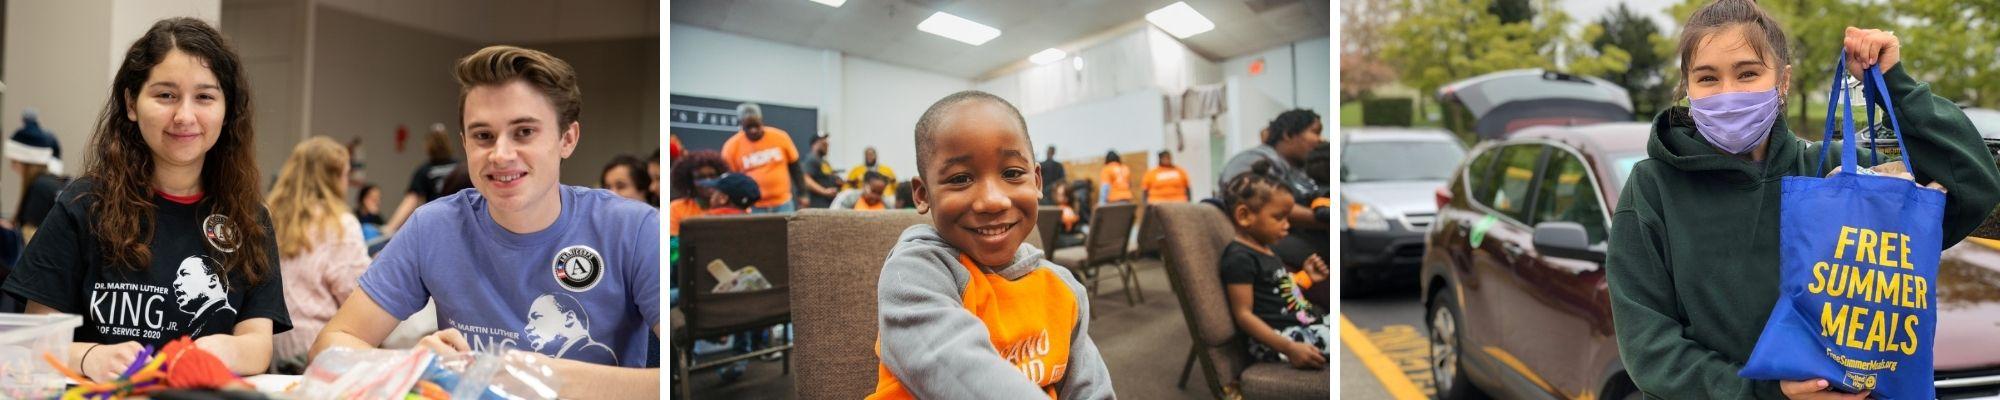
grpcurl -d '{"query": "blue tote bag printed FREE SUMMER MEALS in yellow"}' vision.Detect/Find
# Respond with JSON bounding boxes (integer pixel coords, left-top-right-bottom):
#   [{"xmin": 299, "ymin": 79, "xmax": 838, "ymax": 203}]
[{"xmin": 1738, "ymin": 52, "xmax": 1944, "ymax": 400}]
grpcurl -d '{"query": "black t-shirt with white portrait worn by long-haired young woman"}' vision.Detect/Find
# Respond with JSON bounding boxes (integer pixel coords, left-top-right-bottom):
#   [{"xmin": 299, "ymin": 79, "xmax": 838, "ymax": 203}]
[{"xmin": 0, "ymin": 180, "xmax": 292, "ymax": 346}]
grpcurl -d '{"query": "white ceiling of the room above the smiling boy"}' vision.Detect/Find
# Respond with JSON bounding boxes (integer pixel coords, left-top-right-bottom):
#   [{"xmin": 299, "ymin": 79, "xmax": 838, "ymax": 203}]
[{"xmin": 672, "ymin": 0, "xmax": 1330, "ymax": 78}]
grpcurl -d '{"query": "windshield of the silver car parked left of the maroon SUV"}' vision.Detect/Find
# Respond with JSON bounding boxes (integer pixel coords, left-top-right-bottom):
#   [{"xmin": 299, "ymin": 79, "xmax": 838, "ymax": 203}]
[{"xmin": 1340, "ymin": 140, "xmax": 1466, "ymax": 182}]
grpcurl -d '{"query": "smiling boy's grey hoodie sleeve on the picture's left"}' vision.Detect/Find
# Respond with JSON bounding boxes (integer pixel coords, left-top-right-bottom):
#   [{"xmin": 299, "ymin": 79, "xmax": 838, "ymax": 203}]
[{"xmin": 876, "ymin": 226, "xmax": 1056, "ymax": 398}]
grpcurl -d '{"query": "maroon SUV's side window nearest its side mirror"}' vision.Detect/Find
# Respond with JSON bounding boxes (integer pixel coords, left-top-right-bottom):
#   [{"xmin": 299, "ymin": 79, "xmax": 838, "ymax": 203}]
[{"xmin": 1530, "ymin": 152, "xmax": 1606, "ymax": 244}]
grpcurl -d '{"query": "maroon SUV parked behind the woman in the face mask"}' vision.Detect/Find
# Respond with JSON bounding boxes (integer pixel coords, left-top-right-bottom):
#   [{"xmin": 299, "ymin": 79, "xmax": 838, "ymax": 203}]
[{"xmin": 1420, "ymin": 122, "xmax": 2000, "ymax": 398}]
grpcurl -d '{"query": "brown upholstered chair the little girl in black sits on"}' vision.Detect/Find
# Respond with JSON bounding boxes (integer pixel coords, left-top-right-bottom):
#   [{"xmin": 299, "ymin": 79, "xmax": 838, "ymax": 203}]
[{"xmin": 1148, "ymin": 202, "xmax": 1332, "ymax": 398}]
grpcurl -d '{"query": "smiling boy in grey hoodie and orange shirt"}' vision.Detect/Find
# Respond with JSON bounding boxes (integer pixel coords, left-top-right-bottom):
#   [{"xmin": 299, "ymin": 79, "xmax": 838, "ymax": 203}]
[{"xmin": 868, "ymin": 90, "xmax": 1112, "ymax": 398}]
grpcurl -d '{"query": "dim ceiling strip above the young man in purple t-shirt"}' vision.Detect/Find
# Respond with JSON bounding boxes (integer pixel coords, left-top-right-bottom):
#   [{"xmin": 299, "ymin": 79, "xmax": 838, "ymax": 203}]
[{"xmin": 316, "ymin": 0, "xmax": 660, "ymax": 44}]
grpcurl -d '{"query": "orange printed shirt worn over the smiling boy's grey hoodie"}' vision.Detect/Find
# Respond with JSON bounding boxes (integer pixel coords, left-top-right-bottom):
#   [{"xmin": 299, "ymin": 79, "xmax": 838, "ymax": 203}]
[{"xmin": 868, "ymin": 254, "xmax": 1082, "ymax": 400}]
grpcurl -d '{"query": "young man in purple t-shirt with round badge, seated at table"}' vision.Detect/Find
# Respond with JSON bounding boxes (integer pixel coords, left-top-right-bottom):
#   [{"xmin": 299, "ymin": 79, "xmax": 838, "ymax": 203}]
[{"xmin": 312, "ymin": 46, "xmax": 660, "ymax": 398}]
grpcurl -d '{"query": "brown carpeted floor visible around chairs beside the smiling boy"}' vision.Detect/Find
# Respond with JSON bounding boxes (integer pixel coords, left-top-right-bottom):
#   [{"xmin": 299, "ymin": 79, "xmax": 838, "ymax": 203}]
[{"xmin": 692, "ymin": 258, "xmax": 1256, "ymax": 400}]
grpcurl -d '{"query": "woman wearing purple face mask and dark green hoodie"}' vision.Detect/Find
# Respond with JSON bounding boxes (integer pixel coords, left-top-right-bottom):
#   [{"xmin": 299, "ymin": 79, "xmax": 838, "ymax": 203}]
[{"xmin": 1604, "ymin": 0, "xmax": 2000, "ymax": 398}]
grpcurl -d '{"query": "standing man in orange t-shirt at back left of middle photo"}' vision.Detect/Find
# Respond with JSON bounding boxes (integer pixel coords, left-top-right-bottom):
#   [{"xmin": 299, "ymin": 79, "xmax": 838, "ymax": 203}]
[{"xmin": 722, "ymin": 102, "xmax": 804, "ymax": 214}]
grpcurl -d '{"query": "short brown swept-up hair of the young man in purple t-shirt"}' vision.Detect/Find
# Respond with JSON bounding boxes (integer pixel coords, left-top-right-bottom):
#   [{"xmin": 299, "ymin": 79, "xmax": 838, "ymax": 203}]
[{"xmin": 452, "ymin": 46, "xmax": 584, "ymax": 126}]
